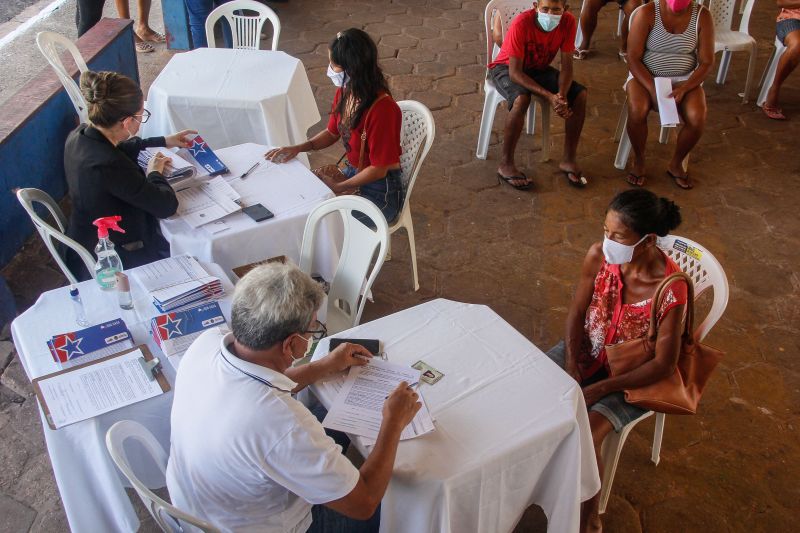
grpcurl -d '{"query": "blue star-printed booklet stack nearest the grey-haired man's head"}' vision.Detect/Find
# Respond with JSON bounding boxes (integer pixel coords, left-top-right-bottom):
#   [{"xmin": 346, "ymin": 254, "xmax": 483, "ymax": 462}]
[{"xmin": 150, "ymin": 302, "xmax": 227, "ymax": 357}]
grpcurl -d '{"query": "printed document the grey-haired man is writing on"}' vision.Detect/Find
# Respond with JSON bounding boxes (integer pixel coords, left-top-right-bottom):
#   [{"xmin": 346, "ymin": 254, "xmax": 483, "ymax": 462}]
[{"xmin": 322, "ymin": 359, "xmax": 434, "ymax": 446}]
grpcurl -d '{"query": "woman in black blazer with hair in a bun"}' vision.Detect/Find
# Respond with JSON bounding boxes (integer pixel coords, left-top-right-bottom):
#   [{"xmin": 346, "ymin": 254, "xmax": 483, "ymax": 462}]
[{"xmin": 64, "ymin": 71, "xmax": 196, "ymax": 279}]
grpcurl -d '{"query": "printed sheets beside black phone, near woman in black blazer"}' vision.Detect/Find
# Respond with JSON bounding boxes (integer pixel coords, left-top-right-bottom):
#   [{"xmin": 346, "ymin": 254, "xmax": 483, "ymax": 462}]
[{"xmin": 177, "ymin": 176, "xmax": 242, "ymax": 228}]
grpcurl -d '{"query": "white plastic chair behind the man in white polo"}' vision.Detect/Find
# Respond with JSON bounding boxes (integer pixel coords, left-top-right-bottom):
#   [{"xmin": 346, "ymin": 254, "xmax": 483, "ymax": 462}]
[{"xmin": 106, "ymin": 420, "xmax": 219, "ymax": 533}]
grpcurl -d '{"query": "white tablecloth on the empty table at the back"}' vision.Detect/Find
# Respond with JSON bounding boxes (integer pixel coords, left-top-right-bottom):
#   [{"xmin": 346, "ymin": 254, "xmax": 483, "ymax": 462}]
[{"xmin": 142, "ymin": 48, "xmax": 320, "ymax": 166}]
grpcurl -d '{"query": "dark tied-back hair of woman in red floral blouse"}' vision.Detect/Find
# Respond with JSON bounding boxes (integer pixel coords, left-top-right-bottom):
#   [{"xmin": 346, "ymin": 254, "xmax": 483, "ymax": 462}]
[{"xmin": 608, "ymin": 189, "xmax": 681, "ymax": 237}]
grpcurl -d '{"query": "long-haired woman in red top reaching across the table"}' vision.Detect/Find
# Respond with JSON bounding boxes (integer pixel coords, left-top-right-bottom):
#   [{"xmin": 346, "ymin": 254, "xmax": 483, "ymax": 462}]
[{"xmin": 266, "ymin": 28, "xmax": 403, "ymax": 222}]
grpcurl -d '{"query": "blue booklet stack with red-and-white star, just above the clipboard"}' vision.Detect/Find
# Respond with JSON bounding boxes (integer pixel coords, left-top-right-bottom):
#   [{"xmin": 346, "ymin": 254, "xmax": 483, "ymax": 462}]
[{"xmin": 47, "ymin": 318, "xmax": 133, "ymax": 367}]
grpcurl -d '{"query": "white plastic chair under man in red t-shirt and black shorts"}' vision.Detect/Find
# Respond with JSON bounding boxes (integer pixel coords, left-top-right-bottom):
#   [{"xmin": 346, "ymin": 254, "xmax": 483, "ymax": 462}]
[{"xmin": 476, "ymin": 0, "xmax": 550, "ymax": 161}]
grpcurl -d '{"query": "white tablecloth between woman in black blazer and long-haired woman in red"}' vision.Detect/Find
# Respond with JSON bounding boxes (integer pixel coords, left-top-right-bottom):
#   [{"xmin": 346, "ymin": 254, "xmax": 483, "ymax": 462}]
[{"xmin": 161, "ymin": 143, "xmax": 343, "ymax": 281}]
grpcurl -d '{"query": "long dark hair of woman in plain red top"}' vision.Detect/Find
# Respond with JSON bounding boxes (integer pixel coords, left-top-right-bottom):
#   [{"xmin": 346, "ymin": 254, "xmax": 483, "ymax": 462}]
[{"xmin": 330, "ymin": 28, "xmax": 390, "ymax": 130}]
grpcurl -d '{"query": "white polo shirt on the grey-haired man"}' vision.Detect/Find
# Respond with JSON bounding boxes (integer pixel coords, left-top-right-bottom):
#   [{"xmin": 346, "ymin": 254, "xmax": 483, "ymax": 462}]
[{"xmin": 167, "ymin": 329, "xmax": 359, "ymax": 532}]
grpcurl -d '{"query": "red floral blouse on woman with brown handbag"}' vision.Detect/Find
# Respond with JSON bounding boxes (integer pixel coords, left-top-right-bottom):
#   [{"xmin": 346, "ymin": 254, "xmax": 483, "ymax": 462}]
[{"xmin": 578, "ymin": 252, "xmax": 686, "ymax": 379}]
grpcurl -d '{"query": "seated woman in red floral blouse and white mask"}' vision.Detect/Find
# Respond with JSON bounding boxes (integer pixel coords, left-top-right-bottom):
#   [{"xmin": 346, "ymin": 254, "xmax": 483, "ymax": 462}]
[{"xmin": 547, "ymin": 189, "xmax": 687, "ymax": 531}]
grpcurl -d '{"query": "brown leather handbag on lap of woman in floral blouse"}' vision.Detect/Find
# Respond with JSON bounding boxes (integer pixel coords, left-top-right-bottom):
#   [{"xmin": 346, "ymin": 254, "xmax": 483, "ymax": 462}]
[{"xmin": 606, "ymin": 272, "xmax": 725, "ymax": 415}]
